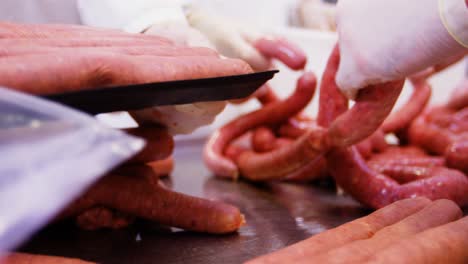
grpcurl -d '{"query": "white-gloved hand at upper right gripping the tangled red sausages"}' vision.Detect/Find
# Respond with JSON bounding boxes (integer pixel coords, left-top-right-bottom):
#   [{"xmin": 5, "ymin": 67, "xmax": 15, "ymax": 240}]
[{"xmin": 336, "ymin": 0, "xmax": 468, "ymax": 98}]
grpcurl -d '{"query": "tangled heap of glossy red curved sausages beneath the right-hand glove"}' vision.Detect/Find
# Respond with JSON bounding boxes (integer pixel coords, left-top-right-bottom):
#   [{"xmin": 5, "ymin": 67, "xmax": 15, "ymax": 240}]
[{"xmin": 204, "ymin": 43, "xmax": 468, "ymax": 208}]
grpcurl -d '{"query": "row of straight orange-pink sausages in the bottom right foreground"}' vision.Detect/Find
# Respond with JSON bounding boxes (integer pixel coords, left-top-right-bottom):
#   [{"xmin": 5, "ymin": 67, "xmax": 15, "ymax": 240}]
[{"xmin": 248, "ymin": 198, "xmax": 468, "ymax": 264}]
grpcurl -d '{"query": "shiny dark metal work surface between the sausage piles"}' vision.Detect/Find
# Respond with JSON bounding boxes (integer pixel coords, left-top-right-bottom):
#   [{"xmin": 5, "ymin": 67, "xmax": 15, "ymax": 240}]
[{"xmin": 20, "ymin": 141, "xmax": 369, "ymax": 264}]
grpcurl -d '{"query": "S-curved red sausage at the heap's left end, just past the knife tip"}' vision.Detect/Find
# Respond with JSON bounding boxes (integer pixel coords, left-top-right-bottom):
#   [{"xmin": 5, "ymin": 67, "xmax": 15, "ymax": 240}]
[{"xmin": 203, "ymin": 72, "xmax": 316, "ymax": 179}]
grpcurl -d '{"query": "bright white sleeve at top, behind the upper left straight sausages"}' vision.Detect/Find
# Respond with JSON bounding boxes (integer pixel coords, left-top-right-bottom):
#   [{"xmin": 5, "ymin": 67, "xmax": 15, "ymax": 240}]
[{"xmin": 77, "ymin": 0, "xmax": 189, "ymax": 33}]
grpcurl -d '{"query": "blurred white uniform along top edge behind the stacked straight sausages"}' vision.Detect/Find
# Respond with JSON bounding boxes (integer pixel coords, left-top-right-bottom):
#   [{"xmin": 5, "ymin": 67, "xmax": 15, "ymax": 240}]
[{"xmin": 0, "ymin": 0, "xmax": 298, "ymax": 32}]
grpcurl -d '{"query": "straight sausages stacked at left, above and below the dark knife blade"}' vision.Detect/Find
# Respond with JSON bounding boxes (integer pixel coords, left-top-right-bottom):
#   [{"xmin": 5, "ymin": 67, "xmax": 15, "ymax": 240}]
[{"xmin": 0, "ymin": 23, "xmax": 252, "ymax": 234}]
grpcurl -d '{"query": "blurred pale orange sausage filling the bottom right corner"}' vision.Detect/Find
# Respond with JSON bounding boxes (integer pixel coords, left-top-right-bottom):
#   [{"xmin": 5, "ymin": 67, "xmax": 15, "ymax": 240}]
[{"xmin": 366, "ymin": 217, "xmax": 468, "ymax": 264}]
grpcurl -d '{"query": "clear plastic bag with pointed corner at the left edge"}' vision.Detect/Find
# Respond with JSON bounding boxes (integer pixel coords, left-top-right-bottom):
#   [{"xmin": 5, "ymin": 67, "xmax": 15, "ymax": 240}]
[{"xmin": 0, "ymin": 88, "xmax": 144, "ymax": 253}]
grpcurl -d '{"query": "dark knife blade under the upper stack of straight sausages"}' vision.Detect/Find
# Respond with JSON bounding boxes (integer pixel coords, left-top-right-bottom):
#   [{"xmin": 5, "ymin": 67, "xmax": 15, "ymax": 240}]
[{"xmin": 42, "ymin": 70, "xmax": 279, "ymax": 114}]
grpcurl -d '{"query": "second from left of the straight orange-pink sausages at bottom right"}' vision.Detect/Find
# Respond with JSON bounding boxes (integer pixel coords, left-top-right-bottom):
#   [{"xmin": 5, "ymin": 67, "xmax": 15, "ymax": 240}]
[{"xmin": 308, "ymin": 200, "xmax": 462, "ymax": 264}]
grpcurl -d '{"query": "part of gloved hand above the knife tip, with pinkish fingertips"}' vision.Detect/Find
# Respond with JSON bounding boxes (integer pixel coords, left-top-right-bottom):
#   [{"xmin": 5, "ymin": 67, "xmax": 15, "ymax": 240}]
[{"xmin": 186, "ymin": 5, "xmax": 306, "ymax": 71}]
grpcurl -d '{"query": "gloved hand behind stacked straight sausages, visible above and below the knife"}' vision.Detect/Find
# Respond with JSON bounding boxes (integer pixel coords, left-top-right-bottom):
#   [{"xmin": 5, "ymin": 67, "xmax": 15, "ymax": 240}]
[{"xmin": 138, "ymin": 6, "xmax": 306, "ymax": 134}]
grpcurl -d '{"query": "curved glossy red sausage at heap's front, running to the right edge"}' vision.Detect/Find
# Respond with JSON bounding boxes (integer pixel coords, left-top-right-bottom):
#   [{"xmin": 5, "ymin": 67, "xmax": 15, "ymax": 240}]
[{"xmin": 327, "ymin": 147, "xmax": 468, "ymax": 208}]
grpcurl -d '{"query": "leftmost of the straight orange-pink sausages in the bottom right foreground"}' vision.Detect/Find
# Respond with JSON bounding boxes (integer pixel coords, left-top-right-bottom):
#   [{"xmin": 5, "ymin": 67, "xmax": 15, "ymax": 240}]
[{"xmin": 249, "ymin": 198, "xmax": 430, "ymax": 264}]
